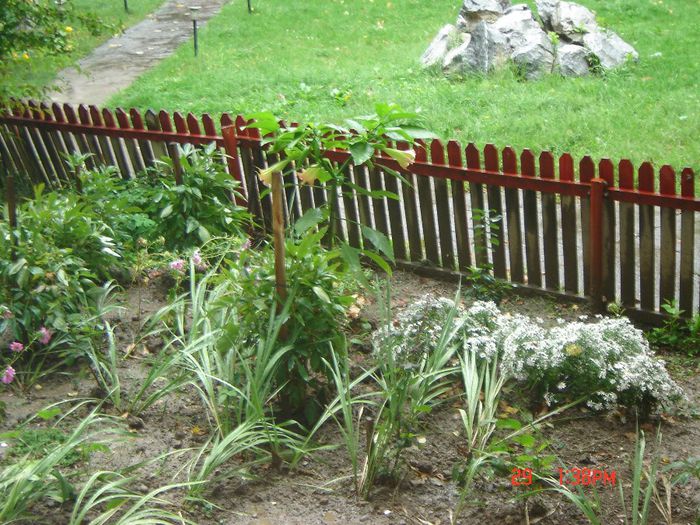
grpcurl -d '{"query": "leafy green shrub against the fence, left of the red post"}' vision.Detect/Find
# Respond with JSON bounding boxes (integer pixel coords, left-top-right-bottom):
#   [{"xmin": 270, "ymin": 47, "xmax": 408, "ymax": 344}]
[{"xmin": 73, "ymin": 144, "xmax": 249, "ymax": 250}]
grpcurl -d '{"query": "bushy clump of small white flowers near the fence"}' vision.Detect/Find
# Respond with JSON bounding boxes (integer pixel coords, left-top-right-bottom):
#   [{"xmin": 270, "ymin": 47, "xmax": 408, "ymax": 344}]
[{"xmin": 375, "ymin": 297, "xmax": 683, "ymax": 413}]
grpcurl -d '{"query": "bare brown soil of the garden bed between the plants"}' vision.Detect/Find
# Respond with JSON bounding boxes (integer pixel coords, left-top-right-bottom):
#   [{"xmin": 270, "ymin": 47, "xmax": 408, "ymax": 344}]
[{"xmin": 0, "ymin": 272, "xmax": 700, "ymax": 525}]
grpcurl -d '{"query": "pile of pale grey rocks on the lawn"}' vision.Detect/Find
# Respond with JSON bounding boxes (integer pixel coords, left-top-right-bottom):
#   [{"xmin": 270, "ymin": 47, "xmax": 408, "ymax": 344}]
[{"xmin": 421, "ymin": 0, "xmax": 639, "ymax": 79}]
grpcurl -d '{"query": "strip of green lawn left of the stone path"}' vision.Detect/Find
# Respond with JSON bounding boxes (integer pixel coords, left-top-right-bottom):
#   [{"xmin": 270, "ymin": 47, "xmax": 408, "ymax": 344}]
[{"xmin": 2, "ymin": 0, "xmax": 164, "ymax": 95}]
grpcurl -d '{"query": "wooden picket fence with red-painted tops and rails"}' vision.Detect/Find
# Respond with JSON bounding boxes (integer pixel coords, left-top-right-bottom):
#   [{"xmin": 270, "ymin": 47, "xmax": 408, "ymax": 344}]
[{"xmin": 0, "ymin": 102, "xmax": 700, "ymax": 322}]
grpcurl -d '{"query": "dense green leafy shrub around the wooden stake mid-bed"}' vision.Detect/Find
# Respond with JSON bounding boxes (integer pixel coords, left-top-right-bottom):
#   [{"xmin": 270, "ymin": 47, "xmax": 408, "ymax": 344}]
[{"xmin": 232, "ymin": 229, "xmax": 353, "ymax": 420}]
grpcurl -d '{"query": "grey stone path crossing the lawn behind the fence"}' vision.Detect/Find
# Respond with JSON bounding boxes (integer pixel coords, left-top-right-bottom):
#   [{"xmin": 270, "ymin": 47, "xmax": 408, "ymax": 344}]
[{"xmin": 51, "ymin": 0, "xmax": 229, "ymax": 105}]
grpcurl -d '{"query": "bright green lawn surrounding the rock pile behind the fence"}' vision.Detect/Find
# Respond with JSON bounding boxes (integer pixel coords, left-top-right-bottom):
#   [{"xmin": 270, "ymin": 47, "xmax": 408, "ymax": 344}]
[{"xmin": 111, "ymin": 0, "xmax": 700, "ymax": 168}]
